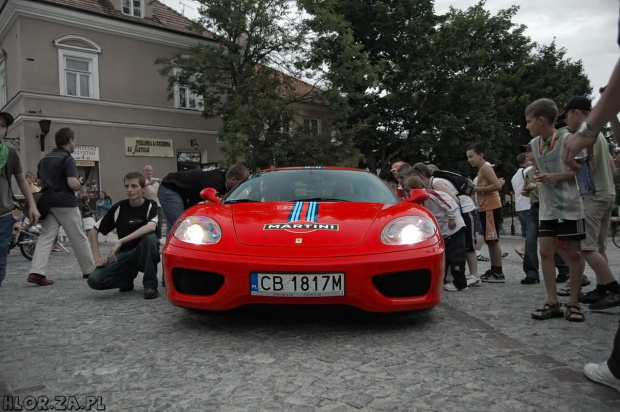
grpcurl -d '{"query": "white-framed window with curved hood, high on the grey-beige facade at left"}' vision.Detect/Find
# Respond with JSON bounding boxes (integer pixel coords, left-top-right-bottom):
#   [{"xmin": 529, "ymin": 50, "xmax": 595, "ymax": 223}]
[{"xmin": 54, "ymin": 35, "xmax": 101, "ymax": 99}]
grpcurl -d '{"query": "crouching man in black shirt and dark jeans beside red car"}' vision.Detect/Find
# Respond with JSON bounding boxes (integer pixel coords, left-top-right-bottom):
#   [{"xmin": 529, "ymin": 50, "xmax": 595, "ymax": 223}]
[{"xmin": 88, "ymin": 172, "xmax": 159, "ymax": 299}]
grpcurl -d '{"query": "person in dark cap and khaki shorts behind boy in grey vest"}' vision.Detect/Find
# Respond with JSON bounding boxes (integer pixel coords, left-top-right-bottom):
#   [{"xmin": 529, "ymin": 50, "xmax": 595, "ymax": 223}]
[{"xmin": 558, "ymin": 96, "xmax": 620, "ymax": 310}]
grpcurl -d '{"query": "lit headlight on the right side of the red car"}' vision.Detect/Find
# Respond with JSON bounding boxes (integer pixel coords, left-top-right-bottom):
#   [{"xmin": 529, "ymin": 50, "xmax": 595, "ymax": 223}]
[{"xmin": 381, "ymin": 216, "xmax": 437, "ymax": 245}]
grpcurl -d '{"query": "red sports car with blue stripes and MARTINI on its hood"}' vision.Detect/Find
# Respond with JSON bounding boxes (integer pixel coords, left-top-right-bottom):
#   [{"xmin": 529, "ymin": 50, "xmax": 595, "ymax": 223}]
[{"xmin": 163, "ymin": 167, "xmax": 444, "ymax": 312}]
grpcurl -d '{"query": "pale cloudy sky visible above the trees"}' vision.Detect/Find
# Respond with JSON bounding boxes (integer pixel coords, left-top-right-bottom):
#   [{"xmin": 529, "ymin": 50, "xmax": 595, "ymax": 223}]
[{"xmin": 160, "ymin": 0, "xmax": 620, "ymax": 100}]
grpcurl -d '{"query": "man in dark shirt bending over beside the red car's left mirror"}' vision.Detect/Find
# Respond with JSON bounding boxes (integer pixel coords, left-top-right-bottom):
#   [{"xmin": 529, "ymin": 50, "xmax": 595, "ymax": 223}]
[{"xmin": 157, "ymin": 163, "xmax": 249, "ymax": 237}]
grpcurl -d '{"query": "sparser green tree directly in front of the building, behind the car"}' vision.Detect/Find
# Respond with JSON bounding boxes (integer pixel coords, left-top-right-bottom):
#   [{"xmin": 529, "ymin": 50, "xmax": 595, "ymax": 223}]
[{"xmin": 156, "ymin": 0, "xmax": 350, "ymax": 169}]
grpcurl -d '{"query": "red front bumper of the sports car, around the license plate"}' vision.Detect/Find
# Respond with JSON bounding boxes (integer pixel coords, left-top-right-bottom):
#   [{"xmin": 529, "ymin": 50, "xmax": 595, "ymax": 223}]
[{"xmin": 163, "ymin": 243, "xmax": 444, "ymax": 312}]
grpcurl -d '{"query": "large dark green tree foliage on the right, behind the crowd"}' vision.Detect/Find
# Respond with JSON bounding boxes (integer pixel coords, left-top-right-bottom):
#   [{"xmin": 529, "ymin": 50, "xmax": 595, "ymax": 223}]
[{"xmin": 300, "ymin": 0, "xmax": 591, "ymax": 177}]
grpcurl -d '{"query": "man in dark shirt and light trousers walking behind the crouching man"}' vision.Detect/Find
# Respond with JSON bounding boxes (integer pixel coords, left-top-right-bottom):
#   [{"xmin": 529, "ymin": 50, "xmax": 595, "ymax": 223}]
[{"xmin": 28, "ymin": 127, "xmax": 95, "ymax": 286}]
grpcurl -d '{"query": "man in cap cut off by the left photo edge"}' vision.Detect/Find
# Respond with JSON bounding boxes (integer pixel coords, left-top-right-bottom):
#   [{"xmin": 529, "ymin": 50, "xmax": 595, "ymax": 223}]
[{"xmin": 0, "ymin": 112, "xmax": 41, "ymax": 286}]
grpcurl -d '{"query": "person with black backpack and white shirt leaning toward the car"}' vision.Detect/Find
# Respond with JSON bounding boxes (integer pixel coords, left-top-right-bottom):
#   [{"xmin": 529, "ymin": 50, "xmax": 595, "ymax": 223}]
[{"xmin": 413, "ymin": 163, "xmax": 482, "ymax": 287}]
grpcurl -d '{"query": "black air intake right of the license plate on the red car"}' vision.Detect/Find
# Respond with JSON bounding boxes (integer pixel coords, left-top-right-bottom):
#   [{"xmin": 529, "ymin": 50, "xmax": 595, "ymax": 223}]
[{"xmin": 372, "ymin": 269, "xmax": 431, "ymax": 298}]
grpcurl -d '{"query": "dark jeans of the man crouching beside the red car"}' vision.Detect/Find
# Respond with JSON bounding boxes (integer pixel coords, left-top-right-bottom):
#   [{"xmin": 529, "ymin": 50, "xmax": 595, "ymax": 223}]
[{"xmin": 88, "ymin": 233, "xmax": 159, "ymax": 290}]
